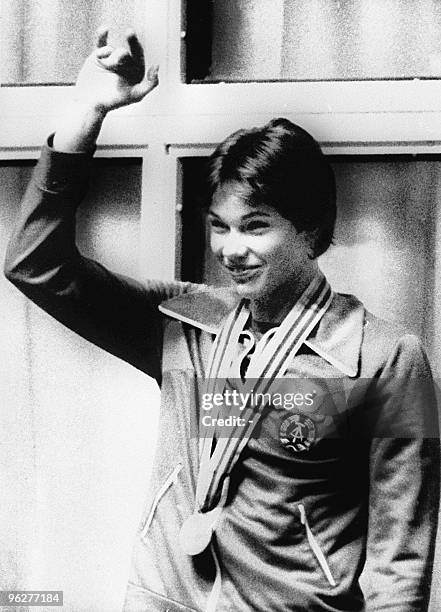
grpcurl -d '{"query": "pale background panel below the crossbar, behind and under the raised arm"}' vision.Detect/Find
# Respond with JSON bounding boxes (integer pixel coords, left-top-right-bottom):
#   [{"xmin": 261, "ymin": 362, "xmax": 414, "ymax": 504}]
[{"xmin": 0, "ymin": 162, "xmax": 158, "ymax": 612}]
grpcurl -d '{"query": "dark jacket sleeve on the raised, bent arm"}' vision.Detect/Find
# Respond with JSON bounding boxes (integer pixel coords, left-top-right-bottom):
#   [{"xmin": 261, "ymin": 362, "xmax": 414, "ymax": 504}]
[{"xmin": 5, "ymin": 137, "xmax": 196, "ymax": 380}]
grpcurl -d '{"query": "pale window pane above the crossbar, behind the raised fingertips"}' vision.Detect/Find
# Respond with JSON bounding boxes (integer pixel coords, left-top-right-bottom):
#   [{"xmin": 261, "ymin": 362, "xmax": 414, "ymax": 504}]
[{"xmin": 0, "ymin": 0, "xmax": 145, "ymax": 84}]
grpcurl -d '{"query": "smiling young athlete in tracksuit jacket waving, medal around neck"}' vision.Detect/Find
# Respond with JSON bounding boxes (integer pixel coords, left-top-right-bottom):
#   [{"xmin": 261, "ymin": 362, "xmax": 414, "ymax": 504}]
[{"xmin": 6, "ymin": 31, "xmax": 439, "ymax": 612}]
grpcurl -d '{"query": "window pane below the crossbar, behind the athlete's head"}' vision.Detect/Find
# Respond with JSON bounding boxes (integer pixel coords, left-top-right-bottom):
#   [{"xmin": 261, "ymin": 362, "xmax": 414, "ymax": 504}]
[{"xmin": 182, "ymin": 156, "xmax": 441, "ymax": 345}]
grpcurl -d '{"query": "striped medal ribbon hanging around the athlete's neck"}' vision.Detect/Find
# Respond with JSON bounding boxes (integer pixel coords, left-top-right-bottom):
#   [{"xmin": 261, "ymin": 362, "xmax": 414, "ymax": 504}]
[{"xmin": 196, "ymin": 274, "xmax": 333, "ymax": 512}]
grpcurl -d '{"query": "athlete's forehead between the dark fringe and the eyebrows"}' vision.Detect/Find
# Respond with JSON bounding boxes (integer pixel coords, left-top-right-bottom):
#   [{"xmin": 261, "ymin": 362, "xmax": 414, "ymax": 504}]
[{"xmin": 208, "ymin": 182, "xmax": 280, "ymax": 217}]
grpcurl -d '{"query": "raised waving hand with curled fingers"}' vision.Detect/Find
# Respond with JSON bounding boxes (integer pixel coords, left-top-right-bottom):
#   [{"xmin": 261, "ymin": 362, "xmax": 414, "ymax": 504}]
[{"xmin": 75, "ymin": 28, "xmax": 159, "ymax": 113}]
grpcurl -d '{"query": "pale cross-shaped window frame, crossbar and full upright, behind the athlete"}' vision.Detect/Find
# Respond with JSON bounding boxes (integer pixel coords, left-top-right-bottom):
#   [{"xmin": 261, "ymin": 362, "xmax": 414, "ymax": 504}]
[{"xmin": 0, "ymin": 0, "xmax": 441, "ymax": 279}]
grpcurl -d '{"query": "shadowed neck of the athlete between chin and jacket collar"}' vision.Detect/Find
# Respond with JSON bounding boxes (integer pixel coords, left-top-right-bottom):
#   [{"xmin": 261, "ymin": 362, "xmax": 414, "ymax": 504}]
[{"xmin": 250, "ymin": 261, "xmax": 319, "ymax": 324}]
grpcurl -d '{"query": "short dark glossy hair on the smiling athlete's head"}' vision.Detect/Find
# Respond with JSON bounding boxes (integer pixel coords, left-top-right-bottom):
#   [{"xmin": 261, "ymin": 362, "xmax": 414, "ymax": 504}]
[{"xmin": 208, "ymin": 118, "xmax": 336, "ymax": 257}]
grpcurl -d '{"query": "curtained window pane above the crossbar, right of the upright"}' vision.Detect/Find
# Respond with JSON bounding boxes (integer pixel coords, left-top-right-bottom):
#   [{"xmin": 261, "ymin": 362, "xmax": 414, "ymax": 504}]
[{"xmin": 187, "ymin": 0, "xmax": 441, "ymax": 81}]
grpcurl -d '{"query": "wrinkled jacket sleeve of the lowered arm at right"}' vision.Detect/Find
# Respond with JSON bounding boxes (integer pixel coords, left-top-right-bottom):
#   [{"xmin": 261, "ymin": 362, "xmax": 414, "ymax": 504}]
[{"xmin": 362, "ymin": 335, "xmax": 440, "ymax": 612}]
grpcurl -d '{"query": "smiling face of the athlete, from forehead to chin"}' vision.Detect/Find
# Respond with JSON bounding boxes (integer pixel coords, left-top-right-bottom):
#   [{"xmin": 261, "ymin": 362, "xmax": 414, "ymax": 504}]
[{"xmin": 208, "ymin": 182, "xmax": 314, "ymax": 300}]
